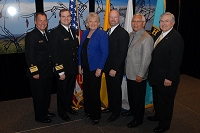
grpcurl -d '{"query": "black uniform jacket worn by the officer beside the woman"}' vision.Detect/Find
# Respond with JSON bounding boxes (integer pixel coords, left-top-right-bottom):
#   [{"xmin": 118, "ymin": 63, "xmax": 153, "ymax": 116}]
[{"xmin": 49, "ymin": 25, "xmax": 79, "ymax": 74}]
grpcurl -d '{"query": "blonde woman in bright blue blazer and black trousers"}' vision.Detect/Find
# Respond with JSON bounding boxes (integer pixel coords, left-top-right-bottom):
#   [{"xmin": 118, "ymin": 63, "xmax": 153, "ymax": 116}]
[{"xmin": 78, "ymin": 12, "xmax": 108, "ymax": 125}]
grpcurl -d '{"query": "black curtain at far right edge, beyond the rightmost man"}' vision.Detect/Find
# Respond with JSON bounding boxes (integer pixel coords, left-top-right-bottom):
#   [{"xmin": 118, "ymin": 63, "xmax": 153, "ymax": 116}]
[{"xmin": 178, "ymin": 0, "xmax": 200, "ymax": 79}]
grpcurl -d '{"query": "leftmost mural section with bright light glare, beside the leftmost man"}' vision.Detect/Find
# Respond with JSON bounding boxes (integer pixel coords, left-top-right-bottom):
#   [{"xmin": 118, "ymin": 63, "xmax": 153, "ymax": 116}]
[{"xmin": 0, "ymin": 0, "xmax": 35, "ymax": 54}]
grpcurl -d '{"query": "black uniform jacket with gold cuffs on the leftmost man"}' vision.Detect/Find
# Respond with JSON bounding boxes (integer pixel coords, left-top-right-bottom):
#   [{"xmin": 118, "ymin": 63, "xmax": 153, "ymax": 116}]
[{"xmin": 25, "ymin": 28, "xmax": 53, "ymax": 78}]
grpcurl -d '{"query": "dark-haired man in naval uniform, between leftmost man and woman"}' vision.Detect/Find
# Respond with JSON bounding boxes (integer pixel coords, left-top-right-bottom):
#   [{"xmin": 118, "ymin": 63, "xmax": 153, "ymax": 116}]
[{"xmin": 50, "ymin": 9, "xmax": 79, "ymax": 121}]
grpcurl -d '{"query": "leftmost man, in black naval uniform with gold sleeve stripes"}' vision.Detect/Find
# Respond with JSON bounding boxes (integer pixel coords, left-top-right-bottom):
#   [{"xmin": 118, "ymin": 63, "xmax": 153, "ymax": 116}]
[{"xmin": 25, "ymin": 13, "xmax": 55, "ymax": 123}]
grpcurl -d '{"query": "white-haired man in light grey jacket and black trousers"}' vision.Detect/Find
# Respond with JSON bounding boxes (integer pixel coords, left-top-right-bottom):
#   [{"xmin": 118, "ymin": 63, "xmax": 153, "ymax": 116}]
[{"xmin": 126, "ymin": 13, "xmax": 154, "ymax": 128}]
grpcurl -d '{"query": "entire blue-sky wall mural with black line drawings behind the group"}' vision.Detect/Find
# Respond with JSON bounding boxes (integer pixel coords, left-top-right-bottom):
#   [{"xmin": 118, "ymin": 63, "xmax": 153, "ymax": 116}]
[{"xmin": 0, "ymin": 0, "xmax": 157, "ymax": 54}]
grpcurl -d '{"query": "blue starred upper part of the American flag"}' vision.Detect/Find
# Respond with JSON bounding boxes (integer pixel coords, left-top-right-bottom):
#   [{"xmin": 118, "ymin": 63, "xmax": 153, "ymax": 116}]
[{"xmin": 69, "ymin": 0, "xmax": 78, "ymax": 33}]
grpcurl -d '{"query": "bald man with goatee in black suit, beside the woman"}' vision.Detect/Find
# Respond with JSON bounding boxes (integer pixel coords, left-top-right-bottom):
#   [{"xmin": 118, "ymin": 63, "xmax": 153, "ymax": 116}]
[{"xmin": 102, "ymin": 10, "xmax": 129, "ymax": 122}]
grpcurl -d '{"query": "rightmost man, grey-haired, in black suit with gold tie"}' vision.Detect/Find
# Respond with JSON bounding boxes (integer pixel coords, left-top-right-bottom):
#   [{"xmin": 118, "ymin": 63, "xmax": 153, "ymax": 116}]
[{"xmin": 147, "ymin": 12, "xmax": 184, "ymax": 132}]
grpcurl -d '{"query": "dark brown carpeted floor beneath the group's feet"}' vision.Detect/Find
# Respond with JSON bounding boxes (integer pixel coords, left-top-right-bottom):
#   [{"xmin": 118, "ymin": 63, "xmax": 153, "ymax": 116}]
[{"xmin": 0, "ymin": 75, "xmax": 200, "ymax": 133}]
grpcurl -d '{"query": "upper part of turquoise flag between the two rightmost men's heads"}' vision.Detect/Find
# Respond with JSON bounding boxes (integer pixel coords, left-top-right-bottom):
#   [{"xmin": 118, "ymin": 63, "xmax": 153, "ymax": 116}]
[{"xmin": 151, "ymin": 0, "xmax": 166, "ymax": 36}]
